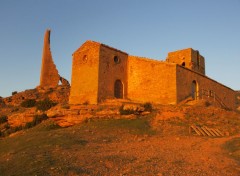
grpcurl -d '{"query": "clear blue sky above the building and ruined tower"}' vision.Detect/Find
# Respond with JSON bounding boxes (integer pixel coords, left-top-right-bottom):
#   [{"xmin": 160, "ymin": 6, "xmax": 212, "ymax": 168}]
[{"xmin": 0, "ymin": 0, "xmax": 240, "ymax": 97}]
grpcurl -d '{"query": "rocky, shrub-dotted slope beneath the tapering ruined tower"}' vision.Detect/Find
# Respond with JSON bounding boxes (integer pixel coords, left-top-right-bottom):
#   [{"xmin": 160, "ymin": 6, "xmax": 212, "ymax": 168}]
[{"xmin": 0, "ymin": 85, "xmax": 70, "ymax": 136}]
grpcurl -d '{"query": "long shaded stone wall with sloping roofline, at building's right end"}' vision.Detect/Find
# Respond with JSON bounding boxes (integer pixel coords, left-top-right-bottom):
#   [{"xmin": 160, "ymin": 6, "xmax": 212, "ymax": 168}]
[{"xmin": 176, "ymin": 65, "xmax": 236, "ymax": 109}]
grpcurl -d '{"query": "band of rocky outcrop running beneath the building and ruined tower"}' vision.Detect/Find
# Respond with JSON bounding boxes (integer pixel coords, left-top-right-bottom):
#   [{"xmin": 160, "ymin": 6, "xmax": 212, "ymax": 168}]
[{"xmin": 0, "ymin": 86, "xmax": 240, "ymax": 136}]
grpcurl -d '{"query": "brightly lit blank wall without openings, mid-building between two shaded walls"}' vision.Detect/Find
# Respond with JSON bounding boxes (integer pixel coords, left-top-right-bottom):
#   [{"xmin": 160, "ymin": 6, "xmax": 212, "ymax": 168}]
[{"xmin": 128, "ymin": 56, "xmax": 176, "ymax": 104}]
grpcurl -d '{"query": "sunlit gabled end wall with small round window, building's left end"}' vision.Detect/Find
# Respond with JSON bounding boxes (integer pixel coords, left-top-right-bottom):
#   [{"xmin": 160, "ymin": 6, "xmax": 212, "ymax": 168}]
[{"xmin": 69, "ymin": 41, "xmax": 100, "ymax": 104}]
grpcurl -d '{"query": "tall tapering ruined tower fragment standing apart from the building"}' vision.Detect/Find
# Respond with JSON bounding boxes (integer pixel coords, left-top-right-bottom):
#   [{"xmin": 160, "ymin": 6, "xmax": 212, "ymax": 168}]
[{"xmin": 40, "ymin": 29, "xmax": 60, "ymax": 87}]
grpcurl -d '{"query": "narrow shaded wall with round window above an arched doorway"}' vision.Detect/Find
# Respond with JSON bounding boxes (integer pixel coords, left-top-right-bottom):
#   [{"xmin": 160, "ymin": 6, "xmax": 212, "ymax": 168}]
[{"xmin": 98, "ymin": 45, "xmax": 128, "ymax": 102}]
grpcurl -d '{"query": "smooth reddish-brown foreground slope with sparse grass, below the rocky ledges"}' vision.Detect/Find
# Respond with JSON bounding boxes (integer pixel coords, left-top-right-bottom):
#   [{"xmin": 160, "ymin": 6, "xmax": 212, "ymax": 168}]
[{"xmin": 0, "ymin": 110, "xmax": 240, "ymax": 176}]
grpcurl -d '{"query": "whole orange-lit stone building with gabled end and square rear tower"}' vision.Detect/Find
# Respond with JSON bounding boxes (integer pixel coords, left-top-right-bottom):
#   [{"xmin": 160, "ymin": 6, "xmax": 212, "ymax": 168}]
[{"xmin": 69, "ymin": 41, "xmax": 235, "ymax": 109}]
